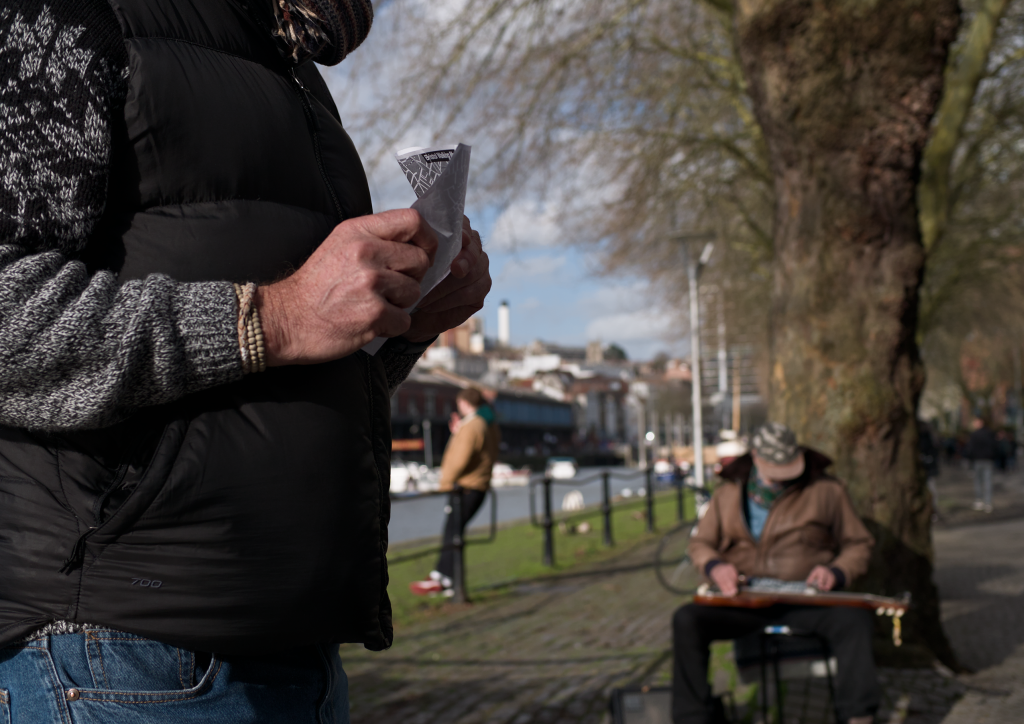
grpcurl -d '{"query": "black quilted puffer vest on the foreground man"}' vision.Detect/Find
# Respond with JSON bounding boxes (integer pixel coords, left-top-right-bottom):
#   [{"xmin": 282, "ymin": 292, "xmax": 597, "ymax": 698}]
[{"xmin": 0, "ymin": 0, "xmax": 391, "ymax": 653}]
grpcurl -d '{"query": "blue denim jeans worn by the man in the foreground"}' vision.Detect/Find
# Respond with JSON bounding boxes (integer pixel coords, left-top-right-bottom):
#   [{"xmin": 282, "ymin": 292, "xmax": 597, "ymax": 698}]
[{"xmin": 0, "ymin": 629, "xmax": 349, "ymax": 724}]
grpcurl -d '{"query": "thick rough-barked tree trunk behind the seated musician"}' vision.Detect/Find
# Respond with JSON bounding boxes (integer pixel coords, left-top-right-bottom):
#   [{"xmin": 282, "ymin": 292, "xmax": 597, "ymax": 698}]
[{"xmin": 736, "ymin": 0, "xmax": 959, "ymax": 666}]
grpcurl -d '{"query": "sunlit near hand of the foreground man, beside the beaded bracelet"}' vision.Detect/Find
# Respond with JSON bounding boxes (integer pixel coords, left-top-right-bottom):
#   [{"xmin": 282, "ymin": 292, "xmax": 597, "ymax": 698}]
[{"xmin": 255, "ymin": 209, "xmax": 437, "ymax": 366}]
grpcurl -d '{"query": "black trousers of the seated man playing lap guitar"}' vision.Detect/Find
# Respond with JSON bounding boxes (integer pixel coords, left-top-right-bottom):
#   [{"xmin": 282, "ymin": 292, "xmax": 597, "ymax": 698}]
[{"xmin": 672, "ymin": 603, "xmax": 882, "ymax": 724}]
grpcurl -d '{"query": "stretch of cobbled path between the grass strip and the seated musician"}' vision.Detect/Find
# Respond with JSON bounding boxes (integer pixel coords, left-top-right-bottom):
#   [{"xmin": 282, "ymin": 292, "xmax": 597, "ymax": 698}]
[{"xmin": 342, "ymin": 548, "xmax": 678, "ymax": 724}]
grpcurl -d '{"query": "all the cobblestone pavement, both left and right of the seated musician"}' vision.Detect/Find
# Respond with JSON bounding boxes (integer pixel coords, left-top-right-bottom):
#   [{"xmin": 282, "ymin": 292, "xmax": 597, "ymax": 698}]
[{"xmin": 342, "ymin": 470, "xmax": 1024, "ymax": 724}]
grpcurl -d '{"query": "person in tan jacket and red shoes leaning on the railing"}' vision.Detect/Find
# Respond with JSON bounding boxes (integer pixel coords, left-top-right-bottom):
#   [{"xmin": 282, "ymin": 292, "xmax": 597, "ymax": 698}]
[{"xmin": 410, "ymin": 387, "xmax": 501, "ymax": 596}]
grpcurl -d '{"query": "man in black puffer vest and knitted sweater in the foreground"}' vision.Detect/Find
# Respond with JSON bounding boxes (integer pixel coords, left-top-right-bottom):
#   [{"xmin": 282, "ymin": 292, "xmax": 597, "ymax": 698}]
[{"xmin": 0, "ymin": 0, "xmax": 490, "ymax": 724}]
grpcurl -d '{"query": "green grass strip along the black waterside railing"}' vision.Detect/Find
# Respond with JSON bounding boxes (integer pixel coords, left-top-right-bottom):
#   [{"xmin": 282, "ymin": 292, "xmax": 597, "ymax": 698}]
[{"xmin": 388, "ymin": 489, "xmax": 695, "ymax": 626}]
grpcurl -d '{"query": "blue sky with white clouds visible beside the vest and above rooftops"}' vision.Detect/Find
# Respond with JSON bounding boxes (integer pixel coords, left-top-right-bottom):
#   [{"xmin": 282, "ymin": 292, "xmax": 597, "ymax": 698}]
[{"xmin": 322, "ymin": 16, "xmax": 686, "ymax": 359}]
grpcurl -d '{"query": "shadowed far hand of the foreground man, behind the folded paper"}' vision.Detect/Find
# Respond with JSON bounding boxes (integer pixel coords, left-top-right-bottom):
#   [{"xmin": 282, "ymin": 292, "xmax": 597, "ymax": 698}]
[{"xmin": 404, "ymin": 217, "xmax": 490, "ymax": 342}]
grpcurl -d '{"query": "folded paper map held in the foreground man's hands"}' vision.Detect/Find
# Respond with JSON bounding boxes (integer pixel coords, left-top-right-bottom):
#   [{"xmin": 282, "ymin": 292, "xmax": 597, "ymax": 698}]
[{"xmin": 362, "ymin": 143, "xmax": 471, "ymax": 354}]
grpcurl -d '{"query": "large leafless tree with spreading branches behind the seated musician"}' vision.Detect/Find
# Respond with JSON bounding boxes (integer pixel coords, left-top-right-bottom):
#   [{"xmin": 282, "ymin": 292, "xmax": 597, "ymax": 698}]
[{"xmin": 342, "ymin": 0, "xmax": 1024, "ymax": 659}]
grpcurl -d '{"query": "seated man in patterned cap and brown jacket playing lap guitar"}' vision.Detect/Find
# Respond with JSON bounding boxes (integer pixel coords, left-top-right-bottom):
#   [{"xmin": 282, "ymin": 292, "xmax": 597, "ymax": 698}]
[{"xmin": 672, "ymin": 422, "xmax": 882, "ymax": 724}]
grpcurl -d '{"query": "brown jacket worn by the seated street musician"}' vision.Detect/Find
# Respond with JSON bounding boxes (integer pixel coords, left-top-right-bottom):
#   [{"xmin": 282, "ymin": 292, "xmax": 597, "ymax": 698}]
[{"xmin": 689, "ymin": 448, "xmax": 874, "ymax": 585}]
